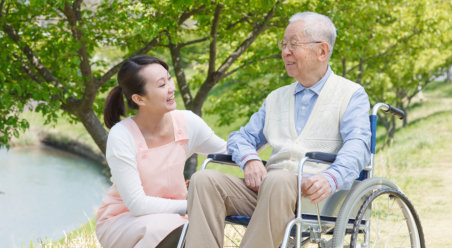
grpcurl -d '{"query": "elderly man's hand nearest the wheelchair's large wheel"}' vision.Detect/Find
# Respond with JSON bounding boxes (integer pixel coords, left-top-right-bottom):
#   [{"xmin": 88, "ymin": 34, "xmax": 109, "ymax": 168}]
[{"xmin": 301, "ymin": 174, "xmax": 331, "ymax": 204}]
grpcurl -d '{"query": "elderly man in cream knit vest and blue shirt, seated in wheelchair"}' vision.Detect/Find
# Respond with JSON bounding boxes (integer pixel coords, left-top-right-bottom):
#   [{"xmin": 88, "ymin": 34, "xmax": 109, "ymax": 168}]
[{"xmin": 186, "ymin": 12, "xmax": 371, "ymax": 248}]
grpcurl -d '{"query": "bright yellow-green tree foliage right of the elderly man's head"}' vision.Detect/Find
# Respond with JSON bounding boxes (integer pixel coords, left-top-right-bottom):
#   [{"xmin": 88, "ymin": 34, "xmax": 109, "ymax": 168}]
[{"xmin": 333, "ymin": 0, "xmax": 451, "ymax": 141}]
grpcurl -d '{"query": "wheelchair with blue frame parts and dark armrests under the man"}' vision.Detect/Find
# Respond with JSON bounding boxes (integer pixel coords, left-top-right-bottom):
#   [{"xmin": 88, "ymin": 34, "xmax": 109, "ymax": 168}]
[{"xmin": 178, "ymin": 103, "xmax": 425, "ymax": 248}]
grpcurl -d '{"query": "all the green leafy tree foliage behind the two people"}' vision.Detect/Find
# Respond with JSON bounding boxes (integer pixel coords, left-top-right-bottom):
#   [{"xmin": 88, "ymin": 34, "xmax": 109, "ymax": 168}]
[{"xmin": 0, "ymin": 0, "xmax": 452, "ymax": 174}]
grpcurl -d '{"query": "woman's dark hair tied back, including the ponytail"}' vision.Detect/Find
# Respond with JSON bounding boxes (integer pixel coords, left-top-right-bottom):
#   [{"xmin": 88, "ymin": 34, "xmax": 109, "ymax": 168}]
[{"xmin": 104, "ymin": 55, "xmax": 168, "ymax": 128}]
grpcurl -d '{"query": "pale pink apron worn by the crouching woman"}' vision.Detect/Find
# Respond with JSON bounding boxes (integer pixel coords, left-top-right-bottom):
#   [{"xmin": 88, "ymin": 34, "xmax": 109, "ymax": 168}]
[{"xmin": 96, "ymin": 110, "xmax": 188, "ymax": 247}]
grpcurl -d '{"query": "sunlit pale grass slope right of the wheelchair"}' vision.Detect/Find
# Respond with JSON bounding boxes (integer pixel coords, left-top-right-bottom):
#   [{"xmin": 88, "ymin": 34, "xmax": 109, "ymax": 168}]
[{"xmin": 374, "ymin": 83, "xmax": 452, "ymax": 247}]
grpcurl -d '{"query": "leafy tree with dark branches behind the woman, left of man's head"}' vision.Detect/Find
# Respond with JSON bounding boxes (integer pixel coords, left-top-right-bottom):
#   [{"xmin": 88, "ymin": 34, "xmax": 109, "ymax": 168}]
[{"xmin": 0, "ymin": 0, "xmax": 287, "ymax": 177}]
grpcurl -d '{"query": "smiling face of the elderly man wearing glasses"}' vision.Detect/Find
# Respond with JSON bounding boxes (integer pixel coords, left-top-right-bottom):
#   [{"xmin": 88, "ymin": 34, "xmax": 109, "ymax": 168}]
[{"xmin": 281, "ymin": 21, "xmax": 318, "ymax": 83}]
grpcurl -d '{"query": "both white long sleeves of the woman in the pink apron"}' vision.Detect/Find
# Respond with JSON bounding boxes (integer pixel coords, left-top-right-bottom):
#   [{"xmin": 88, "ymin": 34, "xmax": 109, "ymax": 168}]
[{"xmin": 106, "ymin": 111, "xmax": 226, "ymax": 216}]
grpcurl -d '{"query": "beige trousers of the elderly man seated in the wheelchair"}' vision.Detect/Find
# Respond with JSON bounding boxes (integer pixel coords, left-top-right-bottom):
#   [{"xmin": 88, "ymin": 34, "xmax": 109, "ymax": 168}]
[{"xmin": 185, "ymin": 170, "xmax": 297, "ymax": 248}]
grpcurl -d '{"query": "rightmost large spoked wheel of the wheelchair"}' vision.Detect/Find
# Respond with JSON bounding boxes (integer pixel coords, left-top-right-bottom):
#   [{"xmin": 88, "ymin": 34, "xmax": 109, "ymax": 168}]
[{"xmin": 350, "ymin": 188, "xmax": 425, "ymax": 247}]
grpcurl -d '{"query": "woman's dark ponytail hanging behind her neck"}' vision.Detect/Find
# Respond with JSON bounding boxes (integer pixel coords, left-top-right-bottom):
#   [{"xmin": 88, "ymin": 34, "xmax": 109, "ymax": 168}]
[{"xmin": 104, "ymin": 86, "xmax": 126, "ymax": 128}]
